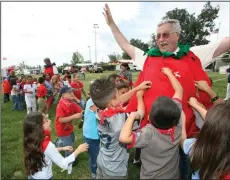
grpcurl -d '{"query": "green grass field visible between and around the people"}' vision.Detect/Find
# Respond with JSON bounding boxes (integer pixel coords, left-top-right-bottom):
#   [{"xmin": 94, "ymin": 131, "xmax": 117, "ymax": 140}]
[{"xmin": 1, "ymin": 72, "xmax": 226, "ymax": 179}]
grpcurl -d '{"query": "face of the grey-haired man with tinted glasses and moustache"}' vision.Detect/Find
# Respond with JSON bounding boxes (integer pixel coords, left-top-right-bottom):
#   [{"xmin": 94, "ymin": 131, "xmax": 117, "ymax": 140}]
[{"xmin": 156, "ymin": 23, "xmax": 179, "ymax": 52}]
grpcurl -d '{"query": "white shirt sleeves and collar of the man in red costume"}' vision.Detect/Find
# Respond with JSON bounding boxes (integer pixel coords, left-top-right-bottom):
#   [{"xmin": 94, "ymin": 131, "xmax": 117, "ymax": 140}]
[{"xmin": 134, "ymin": 39, "xmax": 223, "ymax": 71}]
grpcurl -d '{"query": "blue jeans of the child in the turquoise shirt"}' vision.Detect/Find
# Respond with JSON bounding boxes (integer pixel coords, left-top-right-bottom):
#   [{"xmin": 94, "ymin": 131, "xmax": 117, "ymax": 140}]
[{"xmin": 84, "ymin": 137, "xmax": 100, "ymax": 174}]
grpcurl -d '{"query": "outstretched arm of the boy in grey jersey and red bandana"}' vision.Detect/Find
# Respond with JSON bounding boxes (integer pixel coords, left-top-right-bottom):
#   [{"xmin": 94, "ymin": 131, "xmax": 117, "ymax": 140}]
[{"xmin": 119, "ymin": 81, "xmax": 152, "ymax": 103}]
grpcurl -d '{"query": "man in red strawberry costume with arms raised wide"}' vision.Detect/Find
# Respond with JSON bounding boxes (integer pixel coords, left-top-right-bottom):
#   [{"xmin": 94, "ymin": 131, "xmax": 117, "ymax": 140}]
[{"xmin": 104, "ymin": 4, "xmax": 230, "ymax": 179}]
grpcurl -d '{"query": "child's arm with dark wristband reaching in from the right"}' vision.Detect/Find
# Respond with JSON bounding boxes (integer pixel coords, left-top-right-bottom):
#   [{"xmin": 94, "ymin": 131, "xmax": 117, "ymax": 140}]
[{"xmin": 195, "ymin": 81, "xmax": 224, "ymax": 106}]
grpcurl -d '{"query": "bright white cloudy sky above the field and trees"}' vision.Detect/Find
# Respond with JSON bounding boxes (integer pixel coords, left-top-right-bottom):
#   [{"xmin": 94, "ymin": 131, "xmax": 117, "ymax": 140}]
[{"xmin": 1, "ymin": 2, "xmax": 230, "ymax": 67}]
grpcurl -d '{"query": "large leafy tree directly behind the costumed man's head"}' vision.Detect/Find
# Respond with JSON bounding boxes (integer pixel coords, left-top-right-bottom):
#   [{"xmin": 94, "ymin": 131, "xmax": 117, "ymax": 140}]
[{"xmin": 151, "ymin": 2, "xmax": 220, "ymax": 46}]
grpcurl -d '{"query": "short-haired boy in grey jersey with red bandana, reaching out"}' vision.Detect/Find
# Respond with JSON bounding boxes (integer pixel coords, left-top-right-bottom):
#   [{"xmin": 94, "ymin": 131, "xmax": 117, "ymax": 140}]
[{"xmin": 90, "ymin": 78, "xmax": 151, "ymax": 179}]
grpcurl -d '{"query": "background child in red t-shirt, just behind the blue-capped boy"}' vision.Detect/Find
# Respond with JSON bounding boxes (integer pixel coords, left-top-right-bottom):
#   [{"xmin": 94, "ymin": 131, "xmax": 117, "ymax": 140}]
[{"xmin": 71, "ymin": 73, "xmax": 87, "ymax": 108}]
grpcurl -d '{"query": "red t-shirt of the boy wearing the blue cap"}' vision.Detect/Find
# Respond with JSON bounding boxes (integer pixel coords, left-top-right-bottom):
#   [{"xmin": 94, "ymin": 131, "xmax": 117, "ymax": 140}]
[{"xmin": 55, "ymin": 98, "xmax": 81, "ymax": 137}]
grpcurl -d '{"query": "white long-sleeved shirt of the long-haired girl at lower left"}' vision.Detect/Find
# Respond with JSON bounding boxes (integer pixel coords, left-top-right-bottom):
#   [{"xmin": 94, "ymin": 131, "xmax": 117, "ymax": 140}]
[{"xmin": 31, "ymin": 142, "xmax": 75, "ymax": 179}]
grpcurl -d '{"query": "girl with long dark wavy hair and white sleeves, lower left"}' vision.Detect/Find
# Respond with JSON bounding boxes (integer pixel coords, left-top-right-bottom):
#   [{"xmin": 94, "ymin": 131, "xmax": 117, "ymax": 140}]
[{"xmin": 23, "ymin": 112, "xmax": 88, "ymax": 179}]
